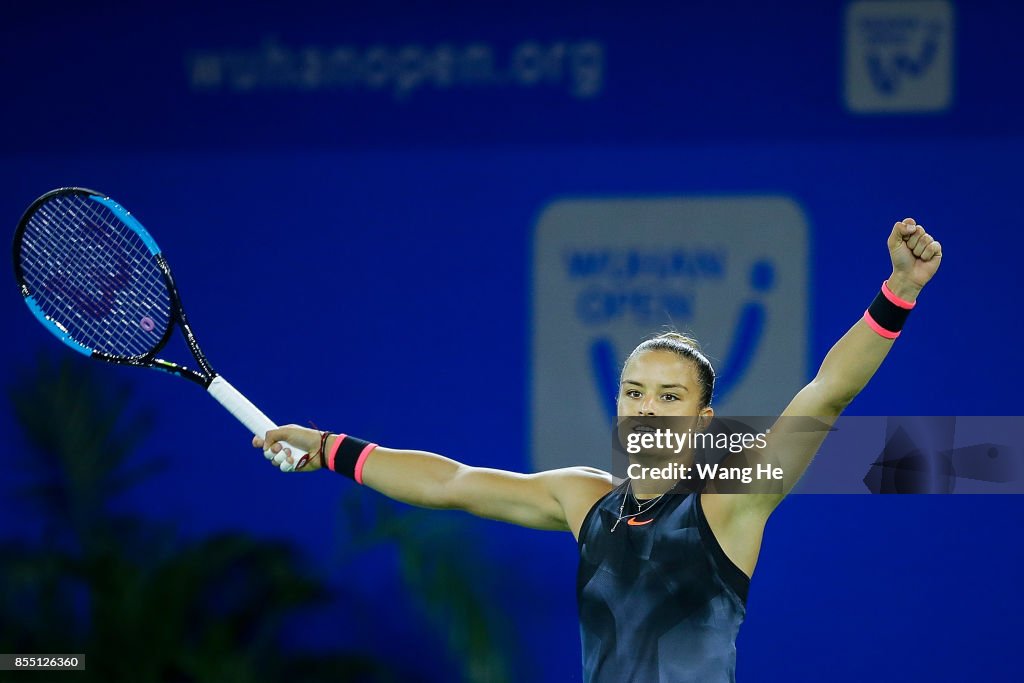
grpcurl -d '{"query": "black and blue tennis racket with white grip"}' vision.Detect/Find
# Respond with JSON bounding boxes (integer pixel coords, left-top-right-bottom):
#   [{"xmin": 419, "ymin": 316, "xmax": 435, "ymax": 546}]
[{"xmin": 14, "ymin": 187, "xmax": 309, "ymax": 471}]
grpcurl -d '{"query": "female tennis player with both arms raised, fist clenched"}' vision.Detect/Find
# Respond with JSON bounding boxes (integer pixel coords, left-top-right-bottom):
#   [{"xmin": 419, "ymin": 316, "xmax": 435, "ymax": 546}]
[{"xmin": 253, "ymin": 218, "xmax": 942, "ymax": 683}]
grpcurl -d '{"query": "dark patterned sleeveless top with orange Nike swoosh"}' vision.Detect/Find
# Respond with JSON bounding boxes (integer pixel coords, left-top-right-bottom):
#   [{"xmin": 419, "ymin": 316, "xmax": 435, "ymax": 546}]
[{"xmin": 577, "ymin": 480, "xmax": 750, "ymax": 683}]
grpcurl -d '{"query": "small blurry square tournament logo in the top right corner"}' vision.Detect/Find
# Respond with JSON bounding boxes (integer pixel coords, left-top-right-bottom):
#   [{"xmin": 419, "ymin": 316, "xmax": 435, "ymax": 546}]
[{"xmin": 846, "ymin": 0, "xmax": 953, "ymax": 114}]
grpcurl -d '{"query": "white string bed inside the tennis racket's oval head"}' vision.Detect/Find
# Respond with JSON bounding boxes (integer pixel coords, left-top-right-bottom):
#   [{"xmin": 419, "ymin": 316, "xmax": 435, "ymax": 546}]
[{"xmin": 20, "ymin": 195, "xmax": 171, "ymax": 356}]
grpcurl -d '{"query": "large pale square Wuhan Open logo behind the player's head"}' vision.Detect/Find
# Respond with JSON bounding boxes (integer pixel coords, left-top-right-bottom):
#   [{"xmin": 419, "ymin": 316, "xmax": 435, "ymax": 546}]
[{"xmin": 529, "ymin": 196, "xmax": 809, "ymax": 470}]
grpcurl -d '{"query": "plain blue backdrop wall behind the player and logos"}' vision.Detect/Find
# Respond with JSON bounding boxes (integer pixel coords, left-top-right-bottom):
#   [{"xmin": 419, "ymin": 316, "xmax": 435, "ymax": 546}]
[{"xmin": 0, "ymin": 2, "xmax": 1024, "ymax": 681}]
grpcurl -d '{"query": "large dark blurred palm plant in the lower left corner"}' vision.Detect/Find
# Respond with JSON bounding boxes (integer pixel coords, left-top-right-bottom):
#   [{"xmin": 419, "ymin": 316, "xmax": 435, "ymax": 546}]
[{"xmin": 0, "ymin": 355, "xmax": 410, "ymax": 683}]
